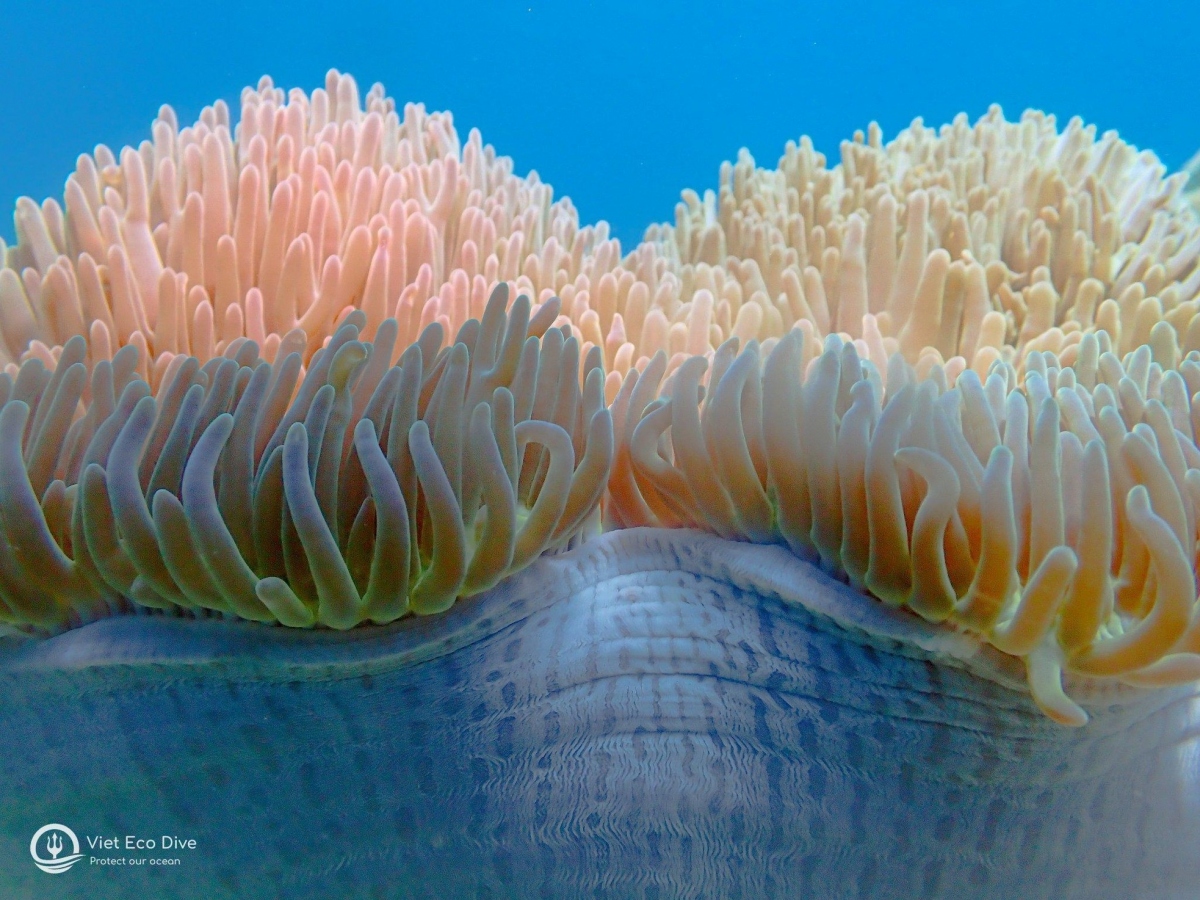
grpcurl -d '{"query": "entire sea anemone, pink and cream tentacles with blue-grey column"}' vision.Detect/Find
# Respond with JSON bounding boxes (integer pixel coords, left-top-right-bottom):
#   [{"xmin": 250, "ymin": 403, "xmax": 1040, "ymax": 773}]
[{"xmin": 0, "ymin": 72, "xmax": 1200, "ymax": 896}]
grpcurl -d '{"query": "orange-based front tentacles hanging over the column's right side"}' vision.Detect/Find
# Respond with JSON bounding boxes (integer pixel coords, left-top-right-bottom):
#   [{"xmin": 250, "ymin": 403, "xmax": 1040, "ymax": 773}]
[{"xmin": 610, "ymin": 331, "xmax": 1200, "ymax": 724}]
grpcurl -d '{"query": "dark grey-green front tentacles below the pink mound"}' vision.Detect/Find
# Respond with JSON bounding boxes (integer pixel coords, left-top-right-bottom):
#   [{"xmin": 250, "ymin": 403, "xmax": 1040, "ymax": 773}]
[{"xmin": 0, "ymin": 284, "xmax": 613, "ymax": 629}]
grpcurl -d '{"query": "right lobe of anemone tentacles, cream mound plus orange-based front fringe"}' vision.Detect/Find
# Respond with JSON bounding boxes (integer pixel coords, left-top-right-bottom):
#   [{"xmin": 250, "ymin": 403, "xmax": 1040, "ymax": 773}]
[{"xmin": 608, "ymin": 107, "xmax": 1200, "ymax": 725}]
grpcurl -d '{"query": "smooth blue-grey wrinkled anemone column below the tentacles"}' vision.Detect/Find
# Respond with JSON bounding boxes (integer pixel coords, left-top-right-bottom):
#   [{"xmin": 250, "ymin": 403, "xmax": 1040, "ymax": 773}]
[{"xmin": 0, "ymin": 529, "xmax": 1200, "ymax": 899}]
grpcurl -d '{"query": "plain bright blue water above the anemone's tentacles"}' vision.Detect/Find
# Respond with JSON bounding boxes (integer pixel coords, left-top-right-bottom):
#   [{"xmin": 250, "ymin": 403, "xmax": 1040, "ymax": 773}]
[{"xmin": 0, "ymin": 0, "xmax": 1200, "ymax": 247}]
